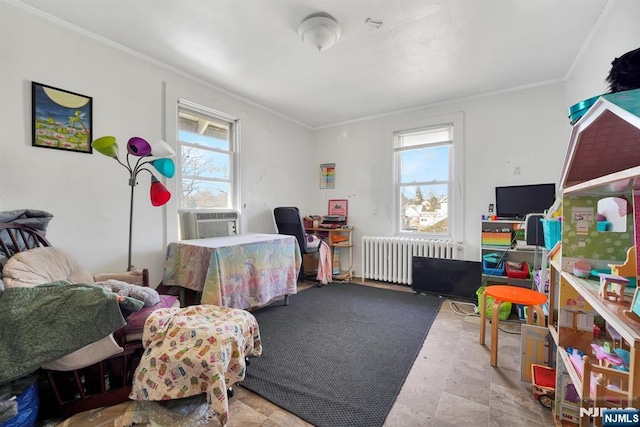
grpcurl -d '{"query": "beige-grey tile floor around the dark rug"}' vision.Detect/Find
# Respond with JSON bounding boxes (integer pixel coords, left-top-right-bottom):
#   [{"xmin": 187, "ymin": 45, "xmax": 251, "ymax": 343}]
[{"xmin": 221, "ymin": 283, "xmax": 554, "ymax": 427}]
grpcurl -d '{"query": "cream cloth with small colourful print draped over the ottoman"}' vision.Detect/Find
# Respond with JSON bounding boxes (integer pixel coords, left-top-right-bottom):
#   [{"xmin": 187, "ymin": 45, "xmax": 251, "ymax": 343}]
[{"xmin": 129, "ymin": 305, "xmax": 262, "ymax": 425}]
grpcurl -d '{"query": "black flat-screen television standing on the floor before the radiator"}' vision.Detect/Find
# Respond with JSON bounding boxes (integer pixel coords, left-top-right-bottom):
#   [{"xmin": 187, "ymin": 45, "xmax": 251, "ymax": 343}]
[{"xmin": 411, "ymin": 257, "xmax": 482, "ymax": 301}]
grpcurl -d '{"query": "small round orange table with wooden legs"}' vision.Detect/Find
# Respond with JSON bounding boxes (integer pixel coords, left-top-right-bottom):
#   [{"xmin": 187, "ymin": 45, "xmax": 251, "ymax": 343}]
[{"xmin": 480, "ymin": 285, "xmax": 547, "ymax": 366}]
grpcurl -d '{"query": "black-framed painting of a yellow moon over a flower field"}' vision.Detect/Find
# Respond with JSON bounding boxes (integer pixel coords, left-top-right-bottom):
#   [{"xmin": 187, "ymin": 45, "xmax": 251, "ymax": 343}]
[{"xmin": 31, "ymin": 82, "xmax": 93, "ymax": 154}]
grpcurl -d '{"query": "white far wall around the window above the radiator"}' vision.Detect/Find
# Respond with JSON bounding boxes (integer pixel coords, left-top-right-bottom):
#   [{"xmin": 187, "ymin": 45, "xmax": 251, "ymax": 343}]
[{"xmin": 313, "ymin": 83, "xmax": 569, "ymax": 274}]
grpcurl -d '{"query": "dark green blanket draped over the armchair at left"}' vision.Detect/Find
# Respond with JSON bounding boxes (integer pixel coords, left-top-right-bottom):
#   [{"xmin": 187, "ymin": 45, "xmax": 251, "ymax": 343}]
[{"xmin": 0, "ymin": 281, "xmax": 142, "ymax": 384}]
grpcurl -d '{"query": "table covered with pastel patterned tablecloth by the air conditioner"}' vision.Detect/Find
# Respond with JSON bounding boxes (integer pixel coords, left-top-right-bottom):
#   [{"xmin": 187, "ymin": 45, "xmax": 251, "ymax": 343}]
[{"xmin": 162, "ymin": 233, "xmax": 302, "ymax": 309}]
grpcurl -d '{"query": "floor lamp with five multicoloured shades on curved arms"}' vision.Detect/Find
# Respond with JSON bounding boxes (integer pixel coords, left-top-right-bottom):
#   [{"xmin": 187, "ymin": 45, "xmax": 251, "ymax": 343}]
[{"xmin": 91, "ymin": 136, "xmax": 176, "ymax": 271}]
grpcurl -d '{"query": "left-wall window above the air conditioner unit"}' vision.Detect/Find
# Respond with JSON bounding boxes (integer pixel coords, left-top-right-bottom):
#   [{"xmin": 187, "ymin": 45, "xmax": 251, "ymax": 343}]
[{"xmin": 177, "ymin": 100, "xmax": 238, "ymax": 210}]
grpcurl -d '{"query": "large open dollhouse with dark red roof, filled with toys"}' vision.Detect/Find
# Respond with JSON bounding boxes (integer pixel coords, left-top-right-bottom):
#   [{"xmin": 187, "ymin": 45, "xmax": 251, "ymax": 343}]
[{"xmin": 548, "ymin": 89, "xmax": 640, "ymax": 426}]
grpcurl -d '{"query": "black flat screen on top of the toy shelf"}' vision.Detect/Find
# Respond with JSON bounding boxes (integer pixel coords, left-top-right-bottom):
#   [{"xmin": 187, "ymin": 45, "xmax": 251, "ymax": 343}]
[{"xmin": 496, "ymin": 184, "xmax": 556, "ymax": 219}]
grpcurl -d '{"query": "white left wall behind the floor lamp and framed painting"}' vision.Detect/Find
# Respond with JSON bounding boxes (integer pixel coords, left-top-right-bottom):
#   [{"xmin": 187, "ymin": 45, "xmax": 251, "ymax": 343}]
[{"xmin": 0, "ymin": 2, "xmax": 316, "ymax": 286}]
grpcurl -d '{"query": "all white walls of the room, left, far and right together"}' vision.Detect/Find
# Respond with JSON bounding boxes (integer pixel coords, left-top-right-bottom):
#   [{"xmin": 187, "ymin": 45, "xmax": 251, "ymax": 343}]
[{"xmin": 0, "ymin": 0, "xmax": 640, "ymax": 284}]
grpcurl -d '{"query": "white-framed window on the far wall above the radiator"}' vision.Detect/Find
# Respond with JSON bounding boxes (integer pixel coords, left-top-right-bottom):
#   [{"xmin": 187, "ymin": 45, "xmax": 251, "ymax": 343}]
[{"xmin": 394, "ymin": 117, "xmax": 462, "ymax": 238}]
